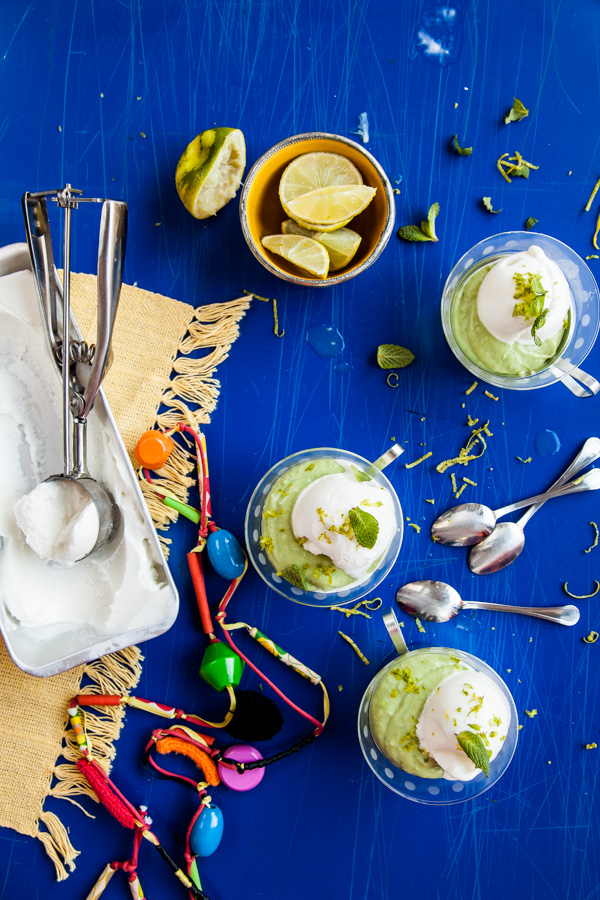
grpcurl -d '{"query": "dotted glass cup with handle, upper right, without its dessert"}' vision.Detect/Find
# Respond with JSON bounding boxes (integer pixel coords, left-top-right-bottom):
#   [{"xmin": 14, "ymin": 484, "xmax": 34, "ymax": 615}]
[{"xmin": 442, "ymin": 231, "xmax": 600, "ymax": 397}]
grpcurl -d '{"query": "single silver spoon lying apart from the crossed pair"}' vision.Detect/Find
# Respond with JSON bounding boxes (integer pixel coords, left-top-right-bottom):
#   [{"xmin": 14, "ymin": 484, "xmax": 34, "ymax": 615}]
[{"xmin": 396, "ymin": 581, "xmax": 579, "ymax": 625}]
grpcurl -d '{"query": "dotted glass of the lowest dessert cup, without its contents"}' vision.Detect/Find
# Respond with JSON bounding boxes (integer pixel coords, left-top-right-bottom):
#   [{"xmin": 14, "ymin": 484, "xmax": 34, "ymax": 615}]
[{"xmin": 358, "ymin": 647, "xmax": 519, "ymax": 806}]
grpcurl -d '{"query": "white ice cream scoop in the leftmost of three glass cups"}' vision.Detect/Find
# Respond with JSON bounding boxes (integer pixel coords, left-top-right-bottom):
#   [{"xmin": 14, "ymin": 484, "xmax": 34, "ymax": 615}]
[{"xmin": 292, "ymin": 470, "xmax": 397, "ymax": 578}]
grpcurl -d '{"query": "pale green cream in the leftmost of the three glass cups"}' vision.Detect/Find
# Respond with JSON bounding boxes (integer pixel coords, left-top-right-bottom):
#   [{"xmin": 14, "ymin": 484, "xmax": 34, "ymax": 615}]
[{"xmin": 261, "ymin": 459, "xmax": 355, "ymax": 591}]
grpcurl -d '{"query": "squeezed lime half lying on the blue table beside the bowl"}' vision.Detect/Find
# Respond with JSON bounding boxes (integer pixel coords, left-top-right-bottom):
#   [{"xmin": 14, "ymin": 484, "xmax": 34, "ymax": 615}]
[{"xmin": 175, "ymin": 128, "xmax": 246, "ymax": 219}]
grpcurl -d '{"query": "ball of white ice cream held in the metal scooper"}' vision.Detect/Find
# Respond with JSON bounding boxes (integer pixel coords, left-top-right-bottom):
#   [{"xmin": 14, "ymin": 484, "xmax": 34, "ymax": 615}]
[{"xmin": 13, "ymin": 479, "xmax": 100, "ymax": 566}]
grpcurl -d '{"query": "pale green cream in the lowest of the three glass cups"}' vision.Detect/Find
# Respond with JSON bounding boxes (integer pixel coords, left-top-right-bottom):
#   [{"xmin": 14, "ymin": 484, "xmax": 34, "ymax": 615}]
[{"xmin": 369, "ymin": 649, "xmax": 469, "ymax": 778}]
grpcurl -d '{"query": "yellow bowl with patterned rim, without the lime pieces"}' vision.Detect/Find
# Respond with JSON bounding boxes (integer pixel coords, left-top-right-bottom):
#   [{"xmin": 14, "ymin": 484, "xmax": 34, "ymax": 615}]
[{"xmin": 240, "ymin": 132, "xmax": 395, "ymax": 287}]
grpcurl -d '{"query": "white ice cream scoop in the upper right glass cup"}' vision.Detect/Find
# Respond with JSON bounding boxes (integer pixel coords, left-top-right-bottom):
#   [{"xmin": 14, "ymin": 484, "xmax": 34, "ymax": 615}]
[{"xmin": 477, "ymin": 244, "xmax": 571, "ymax": 344}]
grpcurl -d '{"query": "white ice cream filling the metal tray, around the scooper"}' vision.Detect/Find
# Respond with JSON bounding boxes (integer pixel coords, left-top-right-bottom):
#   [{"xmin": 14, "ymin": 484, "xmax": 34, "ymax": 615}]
[{"xmin": 0, "ymin": 271, "xmax": 173, "ymax": 640}]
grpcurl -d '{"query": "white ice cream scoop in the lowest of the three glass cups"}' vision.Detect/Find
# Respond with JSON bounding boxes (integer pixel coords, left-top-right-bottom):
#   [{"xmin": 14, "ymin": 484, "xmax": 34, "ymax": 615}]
[{"xmin": 416, "ymin": 671, "xmax": 511, "ymax": 781}]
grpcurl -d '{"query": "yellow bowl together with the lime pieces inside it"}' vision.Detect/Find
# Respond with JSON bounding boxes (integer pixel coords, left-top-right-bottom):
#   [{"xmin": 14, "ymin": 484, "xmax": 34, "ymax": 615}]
[{"xmin": 240, "ymin": 132, "xmax": 395, "ymax": 287}]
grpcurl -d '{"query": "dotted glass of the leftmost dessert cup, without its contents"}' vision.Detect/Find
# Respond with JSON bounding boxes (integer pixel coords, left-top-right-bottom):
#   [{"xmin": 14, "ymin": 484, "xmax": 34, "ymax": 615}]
[{"xmin": 245, "ymin": 447, "xmax": 404, "ymax": 607}]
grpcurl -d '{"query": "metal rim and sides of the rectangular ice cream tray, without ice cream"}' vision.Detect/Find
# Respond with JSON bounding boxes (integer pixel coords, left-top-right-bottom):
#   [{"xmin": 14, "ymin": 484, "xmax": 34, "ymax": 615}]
[{"xmin": 0, "ymin": 243, "xmax": 179, "ymax": 676}]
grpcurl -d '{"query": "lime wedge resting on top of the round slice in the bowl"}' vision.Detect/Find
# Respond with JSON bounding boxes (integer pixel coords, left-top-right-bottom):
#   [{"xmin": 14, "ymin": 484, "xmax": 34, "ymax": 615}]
[{"xmin": 282, "ymin": 184, "xmax": 376, "ymax": 231}]
